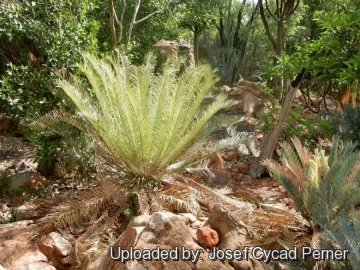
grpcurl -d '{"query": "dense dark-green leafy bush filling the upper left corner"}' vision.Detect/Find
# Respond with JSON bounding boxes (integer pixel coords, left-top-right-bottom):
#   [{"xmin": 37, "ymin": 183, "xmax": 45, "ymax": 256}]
[{"xmin": 0, "ymin": 0, "xmax": 99, "ymax": 120}]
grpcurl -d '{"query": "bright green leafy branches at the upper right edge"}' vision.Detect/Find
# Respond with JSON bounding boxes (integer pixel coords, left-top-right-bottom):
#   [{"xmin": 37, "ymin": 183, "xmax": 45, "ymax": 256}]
[{"xmin": 273, "ymin": 10, "xmax": 360, "ymax": 102}]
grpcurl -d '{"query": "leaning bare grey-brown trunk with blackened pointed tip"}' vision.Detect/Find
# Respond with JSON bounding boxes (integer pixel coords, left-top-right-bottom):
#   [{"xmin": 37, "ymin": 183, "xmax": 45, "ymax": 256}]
[{"xmin": 249, "ymin": 68, "xmax": 305, "ymax": 178}]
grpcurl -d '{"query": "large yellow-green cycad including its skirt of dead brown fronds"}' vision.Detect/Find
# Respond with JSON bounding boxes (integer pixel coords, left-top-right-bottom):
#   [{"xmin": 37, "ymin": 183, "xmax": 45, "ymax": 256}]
[{"xmin": 30, "ymin": 54, "xmax": 264, "ymax": 269}]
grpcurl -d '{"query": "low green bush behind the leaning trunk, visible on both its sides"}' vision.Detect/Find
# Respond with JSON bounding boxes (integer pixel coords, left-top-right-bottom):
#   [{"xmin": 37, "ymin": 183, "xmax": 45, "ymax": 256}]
[{"xmin": 258, "ymin": 105, "xmax": 335, "ymax": 145}]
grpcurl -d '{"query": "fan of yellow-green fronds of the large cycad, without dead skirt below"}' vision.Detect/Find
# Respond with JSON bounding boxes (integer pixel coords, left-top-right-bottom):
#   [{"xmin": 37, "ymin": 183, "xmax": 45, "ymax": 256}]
[{"xmin": 32, "ymin": 54, "xmax": 255, "ymax": 186}]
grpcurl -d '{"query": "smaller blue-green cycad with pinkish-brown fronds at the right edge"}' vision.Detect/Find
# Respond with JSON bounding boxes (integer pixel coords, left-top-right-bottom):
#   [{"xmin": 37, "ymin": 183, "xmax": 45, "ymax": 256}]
[{"xmin": 264, "ymin": 137, "xmax": 360, "ymax": 269}]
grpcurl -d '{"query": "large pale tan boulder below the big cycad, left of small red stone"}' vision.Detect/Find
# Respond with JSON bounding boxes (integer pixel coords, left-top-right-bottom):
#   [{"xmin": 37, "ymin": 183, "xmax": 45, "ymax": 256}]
[{"xmin": 87, "ymin": 212, "xmax": 231, "ymax": 270}]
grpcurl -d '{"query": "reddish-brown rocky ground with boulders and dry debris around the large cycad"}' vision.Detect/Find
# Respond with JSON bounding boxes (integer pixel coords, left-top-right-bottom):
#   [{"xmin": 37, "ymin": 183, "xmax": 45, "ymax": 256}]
[{"xmin": 0, "ymin": 81, "xmax": 311, "ymax": 270}]
